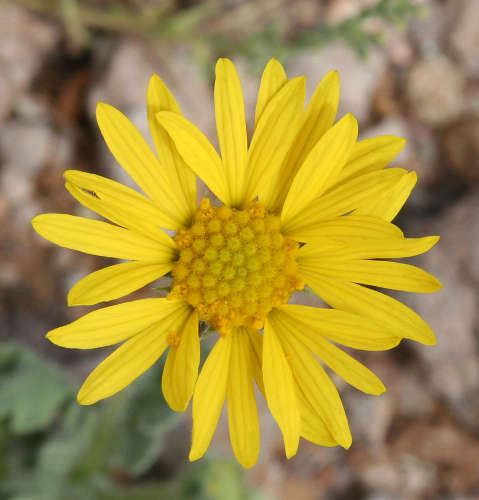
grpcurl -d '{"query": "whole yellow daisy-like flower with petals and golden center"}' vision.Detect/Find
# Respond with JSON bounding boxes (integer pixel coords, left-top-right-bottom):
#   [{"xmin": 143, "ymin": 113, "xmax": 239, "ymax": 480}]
[{"xmin": 32, "ymin": 59, "xmax": 441, "ymax": 467}]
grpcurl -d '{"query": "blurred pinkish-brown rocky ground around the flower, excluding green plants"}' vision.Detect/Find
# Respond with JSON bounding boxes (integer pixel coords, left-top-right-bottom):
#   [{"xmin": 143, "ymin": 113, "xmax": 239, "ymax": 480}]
[{"xmin": 0, "ymin": 0, "xmax": 479, "ymax": 500}]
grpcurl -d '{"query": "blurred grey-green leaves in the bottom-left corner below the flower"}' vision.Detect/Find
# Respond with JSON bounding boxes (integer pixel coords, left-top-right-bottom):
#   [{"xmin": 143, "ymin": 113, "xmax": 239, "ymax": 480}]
[{"xmin": 0, "ymin": 342, "xmax": 259, "ymax": 500}]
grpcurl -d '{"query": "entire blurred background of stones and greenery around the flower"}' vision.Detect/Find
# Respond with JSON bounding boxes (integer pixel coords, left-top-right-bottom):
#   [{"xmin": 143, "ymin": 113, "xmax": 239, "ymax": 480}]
[{"xmin": 0, "ymin": 0, "xmax": 479, "ymax": 500}]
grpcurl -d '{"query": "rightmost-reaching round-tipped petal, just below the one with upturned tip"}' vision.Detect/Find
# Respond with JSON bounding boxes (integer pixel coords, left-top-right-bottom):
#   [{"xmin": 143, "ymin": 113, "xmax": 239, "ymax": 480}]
[{"xmin": 309, "ymin": 257, "xmax": 442, "ymax": 293}]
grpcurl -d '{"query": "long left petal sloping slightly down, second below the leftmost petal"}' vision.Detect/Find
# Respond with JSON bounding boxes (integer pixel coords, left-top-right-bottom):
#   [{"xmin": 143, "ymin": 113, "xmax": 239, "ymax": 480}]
[{"xmin": 47, "ymin": 299, "xmax": 189, "ymax": 349}]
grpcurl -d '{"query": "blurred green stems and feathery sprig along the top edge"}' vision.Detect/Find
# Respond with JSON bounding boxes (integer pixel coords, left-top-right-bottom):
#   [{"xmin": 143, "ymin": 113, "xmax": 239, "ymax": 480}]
[{"xmin": 17, "ymin": 0, "xmax": 422, "ymax": 66}]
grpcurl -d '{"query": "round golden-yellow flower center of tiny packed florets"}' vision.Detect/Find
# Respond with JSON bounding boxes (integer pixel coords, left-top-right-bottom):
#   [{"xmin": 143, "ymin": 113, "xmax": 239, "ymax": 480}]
[{"xmin": 171, "ymin": 198, "xmax": 304, "ymax": 335}]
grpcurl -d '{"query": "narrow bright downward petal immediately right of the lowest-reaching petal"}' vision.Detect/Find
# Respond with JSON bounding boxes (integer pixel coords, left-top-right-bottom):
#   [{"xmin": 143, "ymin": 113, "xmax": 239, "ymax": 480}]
[{"xmin": 263, "ymin": 316, "xmax": 301, "ymax": 458}]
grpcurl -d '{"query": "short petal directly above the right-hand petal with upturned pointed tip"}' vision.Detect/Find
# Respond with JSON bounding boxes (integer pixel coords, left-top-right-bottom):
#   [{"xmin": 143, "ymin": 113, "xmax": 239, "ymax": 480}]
[{"xmin": 285, "ymin": 215, "xmax": 403, "ymax": 248}]
